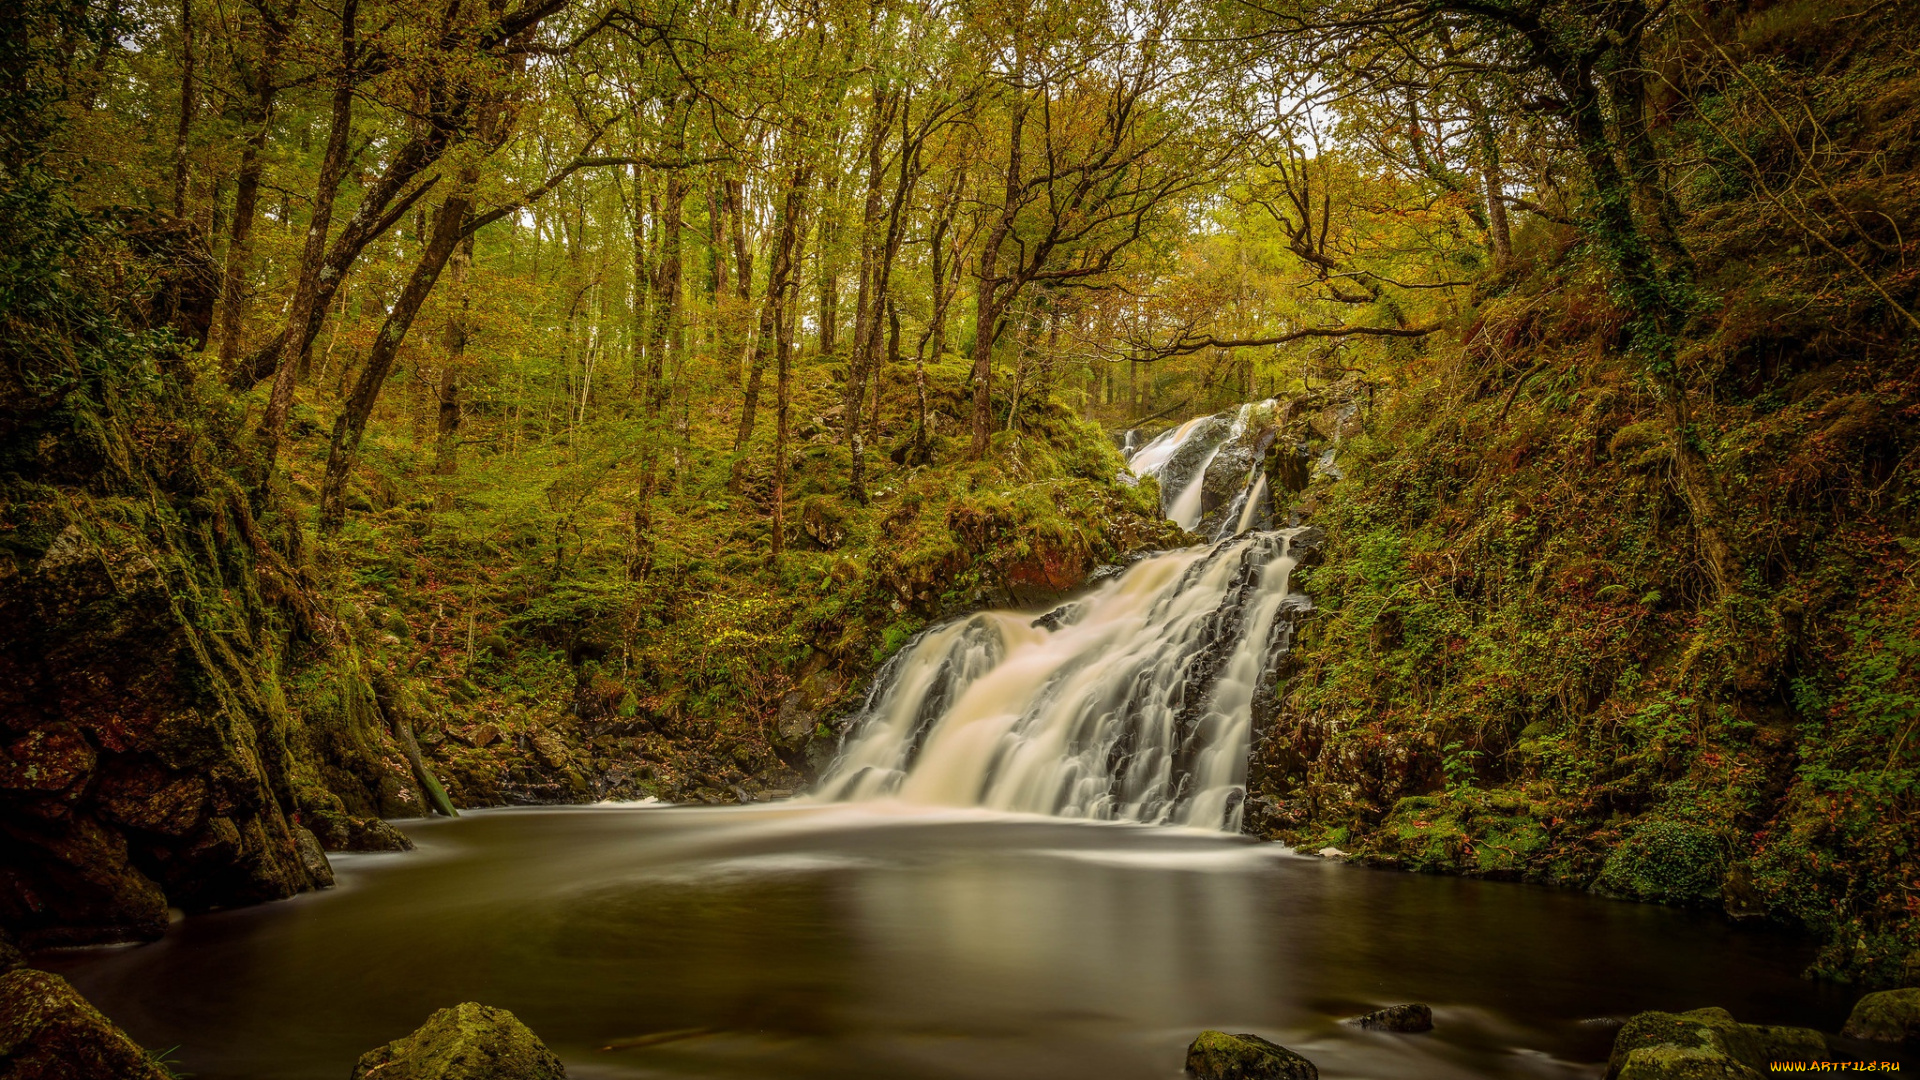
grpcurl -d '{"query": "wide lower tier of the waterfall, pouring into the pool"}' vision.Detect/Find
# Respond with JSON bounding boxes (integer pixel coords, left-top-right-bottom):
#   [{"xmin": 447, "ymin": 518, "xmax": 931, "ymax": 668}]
[{"xmin": 818, "ymin": 526, "xmax": 1306, "ymax": 830}]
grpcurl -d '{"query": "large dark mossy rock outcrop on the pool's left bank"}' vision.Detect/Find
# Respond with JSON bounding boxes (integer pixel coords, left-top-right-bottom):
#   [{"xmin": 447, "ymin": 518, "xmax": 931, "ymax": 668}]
[{"xmin": 0, "ymin": 500, "xmax": 353, "ymax": 947}]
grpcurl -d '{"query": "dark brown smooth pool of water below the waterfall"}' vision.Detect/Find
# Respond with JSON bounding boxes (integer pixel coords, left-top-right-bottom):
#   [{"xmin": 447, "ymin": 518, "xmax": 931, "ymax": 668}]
[{"xmin": 38, "ymin": 803, "xmax": 1889, "ymax": 1080}]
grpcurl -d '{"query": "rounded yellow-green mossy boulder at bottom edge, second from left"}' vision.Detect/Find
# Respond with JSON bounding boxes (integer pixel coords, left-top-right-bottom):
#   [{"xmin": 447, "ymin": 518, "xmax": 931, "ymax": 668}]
[{"xmin": 353, "ymin": 1001, "xmax": 566, "ymax": 1080}]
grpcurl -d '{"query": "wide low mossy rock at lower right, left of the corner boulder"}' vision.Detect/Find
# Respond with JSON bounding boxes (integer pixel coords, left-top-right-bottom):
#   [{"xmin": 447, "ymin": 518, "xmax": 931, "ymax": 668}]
[{"xmin": 1607, "ymin": 1009, "xmax": 1828, "ymax": 1080}]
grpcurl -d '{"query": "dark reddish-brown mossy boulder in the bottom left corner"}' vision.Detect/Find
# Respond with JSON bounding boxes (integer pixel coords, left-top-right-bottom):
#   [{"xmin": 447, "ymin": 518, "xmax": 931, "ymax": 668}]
[{"xmin": 0, "ymin": 969, "xmax": 167, "ymax": 1080}]
